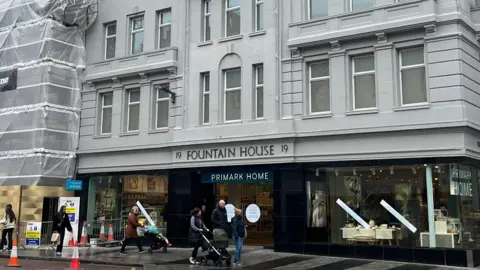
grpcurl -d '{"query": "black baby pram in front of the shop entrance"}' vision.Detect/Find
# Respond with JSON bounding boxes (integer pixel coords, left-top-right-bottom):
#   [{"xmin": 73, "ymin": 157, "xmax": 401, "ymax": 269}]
[{"xmin": 200, "ymin": 229, "xmax": 232, "ymax": 267}]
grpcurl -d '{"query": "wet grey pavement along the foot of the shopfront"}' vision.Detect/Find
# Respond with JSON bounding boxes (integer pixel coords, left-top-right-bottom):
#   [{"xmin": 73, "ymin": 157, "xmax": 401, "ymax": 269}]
[{"xmin": 0, "ymin": 247, "xmax": 472, "ymax": 270}]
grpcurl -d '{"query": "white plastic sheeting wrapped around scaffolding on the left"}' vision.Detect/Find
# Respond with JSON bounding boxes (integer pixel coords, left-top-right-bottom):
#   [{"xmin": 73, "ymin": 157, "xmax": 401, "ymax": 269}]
[{"xmin": 0, "ymin": 0, "xmax": 96, "ymax": 186}]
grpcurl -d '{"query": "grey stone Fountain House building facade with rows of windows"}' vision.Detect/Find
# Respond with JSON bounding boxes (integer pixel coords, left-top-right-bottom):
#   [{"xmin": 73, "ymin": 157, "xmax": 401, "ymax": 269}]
[{"xmin": 78, "ymin": 0, "xmax": 480, "ymax": 265}]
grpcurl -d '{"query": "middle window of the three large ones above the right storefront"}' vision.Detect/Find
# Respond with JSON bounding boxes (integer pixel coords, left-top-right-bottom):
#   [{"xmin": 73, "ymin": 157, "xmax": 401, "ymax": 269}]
[{"xmin": 352, "ymin": 55, "xmax": 377, "ymax": 110}]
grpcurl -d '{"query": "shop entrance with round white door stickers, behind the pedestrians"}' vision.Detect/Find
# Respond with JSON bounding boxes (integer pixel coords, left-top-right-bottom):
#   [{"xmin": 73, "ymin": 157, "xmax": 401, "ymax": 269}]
[{"xmin": 215, "ymin": 181, "xmax": 273, "ymax": 246}]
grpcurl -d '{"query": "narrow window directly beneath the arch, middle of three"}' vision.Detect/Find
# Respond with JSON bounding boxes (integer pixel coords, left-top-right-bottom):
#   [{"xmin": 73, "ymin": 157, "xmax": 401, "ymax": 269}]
[{"xmin": 223, "ymin": 68, "xmax": 242, "ymax": 122}]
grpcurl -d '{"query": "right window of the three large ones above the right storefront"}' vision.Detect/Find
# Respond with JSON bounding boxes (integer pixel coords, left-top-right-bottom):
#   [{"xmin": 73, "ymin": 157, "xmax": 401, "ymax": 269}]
[{"xmin": 399, "ymin": 47, "xmax": 427, "ymax": 105}]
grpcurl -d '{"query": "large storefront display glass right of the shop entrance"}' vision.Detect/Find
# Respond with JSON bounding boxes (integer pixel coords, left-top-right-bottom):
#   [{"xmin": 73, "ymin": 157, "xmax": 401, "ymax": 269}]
[{"xmin": 306, "ymin": 164, "xmax": 480, "ymax": 248}]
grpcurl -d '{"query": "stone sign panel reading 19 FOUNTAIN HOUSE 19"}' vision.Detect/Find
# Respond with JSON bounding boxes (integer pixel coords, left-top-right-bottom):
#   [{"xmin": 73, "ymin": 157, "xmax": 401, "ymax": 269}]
[{"xmin": 173, "ymin": 143, "xmax": 293, "ymax": 162}]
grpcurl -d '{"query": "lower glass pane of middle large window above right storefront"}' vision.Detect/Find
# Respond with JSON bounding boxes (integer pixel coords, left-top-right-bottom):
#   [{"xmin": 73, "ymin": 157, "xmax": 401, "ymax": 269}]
[{"xmin": 355, "ymin": 74, "xmax": 377, "ymax": 109}]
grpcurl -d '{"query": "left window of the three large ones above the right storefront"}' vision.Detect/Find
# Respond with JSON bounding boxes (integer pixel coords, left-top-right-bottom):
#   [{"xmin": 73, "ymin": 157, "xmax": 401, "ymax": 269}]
[{"xmin": 309, "ymin": 60, "xmax": 330, "ymax": 113}]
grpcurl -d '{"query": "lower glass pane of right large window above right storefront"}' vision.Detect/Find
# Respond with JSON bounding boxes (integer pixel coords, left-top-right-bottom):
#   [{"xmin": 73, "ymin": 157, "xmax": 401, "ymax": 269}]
[{"xmin": 401, "ymin": 67, "xmax": 427, "ymax": 104}]
